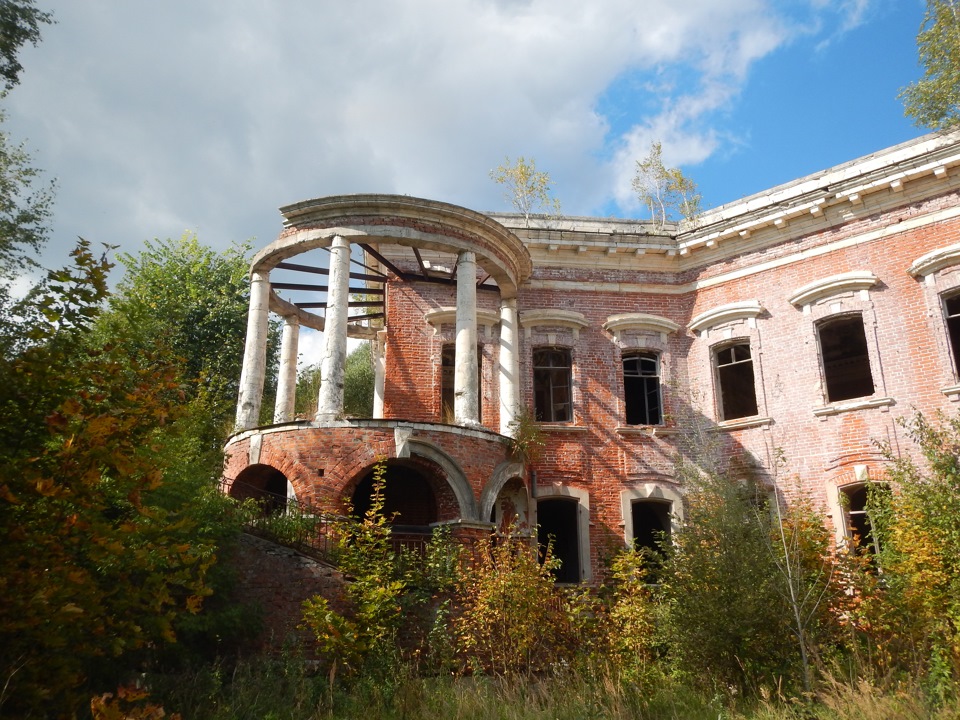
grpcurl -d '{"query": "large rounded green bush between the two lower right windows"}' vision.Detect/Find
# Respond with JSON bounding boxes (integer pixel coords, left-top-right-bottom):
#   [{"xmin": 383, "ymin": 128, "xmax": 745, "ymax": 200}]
[{"xmin": 658, "ymin": 464, "xmax": 795, "ymax": 691}]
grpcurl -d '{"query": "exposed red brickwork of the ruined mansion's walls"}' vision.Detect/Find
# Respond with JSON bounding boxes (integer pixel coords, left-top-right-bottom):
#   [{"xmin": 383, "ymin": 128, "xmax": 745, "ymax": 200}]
[{"xmin": 226, "ymin": 135, "xmax": 960, "ymax": 577}]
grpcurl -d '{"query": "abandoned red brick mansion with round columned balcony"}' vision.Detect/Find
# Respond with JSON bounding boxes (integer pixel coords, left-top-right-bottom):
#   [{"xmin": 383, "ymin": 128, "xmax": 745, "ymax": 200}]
[{"xmin": 225, "ymin": 128, "xmax": 960, "ymax": 582}]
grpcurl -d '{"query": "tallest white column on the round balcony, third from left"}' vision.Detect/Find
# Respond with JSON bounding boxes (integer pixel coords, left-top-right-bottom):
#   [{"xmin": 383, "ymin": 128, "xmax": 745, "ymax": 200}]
[{"xmin": 317, "ymin": 235, "xmax": 350, "ymax": 422}]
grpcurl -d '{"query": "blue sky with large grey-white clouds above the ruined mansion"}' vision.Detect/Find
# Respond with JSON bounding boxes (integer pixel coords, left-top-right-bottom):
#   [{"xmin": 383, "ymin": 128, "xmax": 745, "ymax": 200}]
[{"xmin": 3, "ymin": 0, "xmax": 925, "ymax": 278}]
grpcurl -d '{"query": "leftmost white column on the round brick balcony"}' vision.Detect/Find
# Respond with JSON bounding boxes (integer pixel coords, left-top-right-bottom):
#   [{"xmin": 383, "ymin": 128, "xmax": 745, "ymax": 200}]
[{"xmin": 236, "ymin": 270, "xmax": 270, "ymax": 430}]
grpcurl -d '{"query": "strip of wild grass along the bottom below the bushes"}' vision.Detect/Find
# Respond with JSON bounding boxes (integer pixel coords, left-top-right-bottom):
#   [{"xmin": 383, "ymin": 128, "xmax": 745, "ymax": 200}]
[{"xmin": 142, "ymin": 656, "xmax": 960, "ymax": 720}]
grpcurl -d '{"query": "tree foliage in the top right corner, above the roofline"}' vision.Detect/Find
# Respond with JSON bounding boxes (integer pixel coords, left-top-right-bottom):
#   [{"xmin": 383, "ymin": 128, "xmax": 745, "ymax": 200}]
[{"xmin": 899, "ymin": 0, "xmax": 960, "ymax": 129}]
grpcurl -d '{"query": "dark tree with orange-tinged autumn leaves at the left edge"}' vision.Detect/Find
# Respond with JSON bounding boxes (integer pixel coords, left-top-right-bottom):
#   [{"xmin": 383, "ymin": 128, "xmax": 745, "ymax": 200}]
[{"xmin": 0, "ymin": 241, "xmax": 224, "ymax": 716}]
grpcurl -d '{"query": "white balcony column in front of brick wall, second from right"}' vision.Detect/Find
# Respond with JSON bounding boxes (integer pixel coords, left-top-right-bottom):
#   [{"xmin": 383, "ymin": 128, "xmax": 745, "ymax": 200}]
[{"xmin": 453, "ymin": 251, "xmax": 480, "ymax": 425}]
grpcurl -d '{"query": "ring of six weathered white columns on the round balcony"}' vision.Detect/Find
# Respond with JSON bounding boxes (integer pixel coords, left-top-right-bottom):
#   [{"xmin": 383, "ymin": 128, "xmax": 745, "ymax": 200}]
[{"xmin": 236, "ymin": 235, "xmax": 520, "ymax": 435}]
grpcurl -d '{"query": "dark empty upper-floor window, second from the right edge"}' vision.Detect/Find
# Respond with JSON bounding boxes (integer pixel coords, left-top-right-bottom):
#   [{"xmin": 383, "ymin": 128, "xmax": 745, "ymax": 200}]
[{"xmin": 817, "ymin": 315, "xmax": 873, "ymax": 402}]
